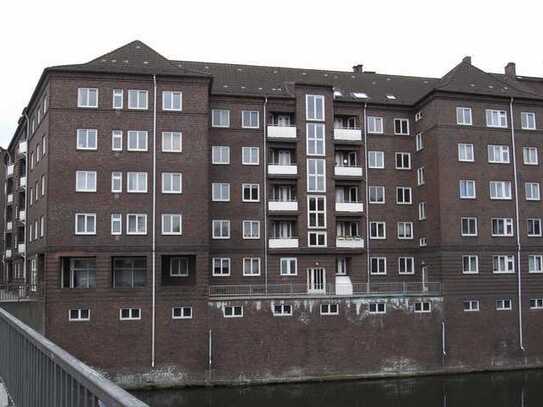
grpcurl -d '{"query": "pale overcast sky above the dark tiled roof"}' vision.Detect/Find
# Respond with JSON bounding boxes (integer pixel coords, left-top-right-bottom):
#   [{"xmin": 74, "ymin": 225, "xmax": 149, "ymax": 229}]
[{"xmin": 0, "ymin": 0, "xmax": 543, "ymax": 146}]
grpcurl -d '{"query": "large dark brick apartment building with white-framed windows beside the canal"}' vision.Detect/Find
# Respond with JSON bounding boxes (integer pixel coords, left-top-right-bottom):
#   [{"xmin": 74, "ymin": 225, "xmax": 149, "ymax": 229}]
[{"xmin": 3, "ymin": 41, "xmax": 543, "ymax": 386}]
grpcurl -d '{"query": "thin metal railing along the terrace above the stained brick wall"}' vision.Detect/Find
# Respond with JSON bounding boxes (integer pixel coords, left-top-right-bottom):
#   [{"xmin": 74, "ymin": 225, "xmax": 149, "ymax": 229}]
[{"xmin": 209, "ymin": 281, "xmax": 441, "ymax": 297}]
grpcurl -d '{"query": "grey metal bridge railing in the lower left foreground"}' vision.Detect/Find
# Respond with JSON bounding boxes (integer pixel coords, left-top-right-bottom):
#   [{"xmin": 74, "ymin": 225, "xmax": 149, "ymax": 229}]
[{"xmin": 0, "ymin": 308, "xmax": 148, "ymax": 407}]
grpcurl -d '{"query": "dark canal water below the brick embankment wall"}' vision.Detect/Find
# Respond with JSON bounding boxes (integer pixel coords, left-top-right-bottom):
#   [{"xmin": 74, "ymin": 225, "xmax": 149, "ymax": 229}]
[{"xmin": 134, "ymin": 370, "xmax": 543, "ymax": 407}]
